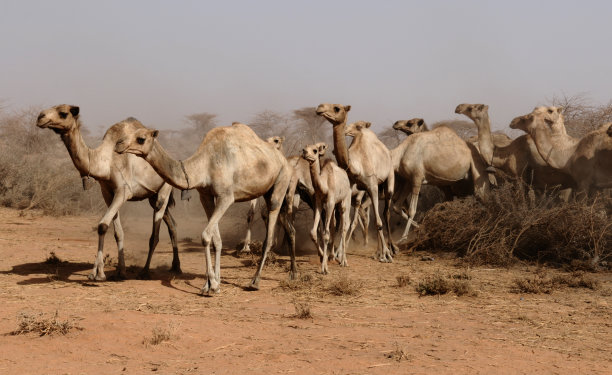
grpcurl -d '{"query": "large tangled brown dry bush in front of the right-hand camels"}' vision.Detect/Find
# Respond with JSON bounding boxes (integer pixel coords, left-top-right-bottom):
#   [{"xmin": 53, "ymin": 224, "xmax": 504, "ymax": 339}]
[{"xmin": 412, "ymin": 183, "xmax": 612, "ymax": 266}]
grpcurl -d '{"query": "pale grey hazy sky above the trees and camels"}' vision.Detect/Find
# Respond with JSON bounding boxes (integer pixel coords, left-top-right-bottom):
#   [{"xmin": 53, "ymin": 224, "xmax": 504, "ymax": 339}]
[{"xmin": 0, "ymin": 0, "xmax": 612, "ymax": 134}]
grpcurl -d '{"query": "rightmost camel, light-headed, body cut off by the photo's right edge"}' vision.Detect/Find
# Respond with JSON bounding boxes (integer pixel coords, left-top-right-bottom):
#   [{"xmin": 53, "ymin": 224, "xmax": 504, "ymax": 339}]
[{"xmin": 510, "ymin": 106, "xmax": 612, "ymax": 194}]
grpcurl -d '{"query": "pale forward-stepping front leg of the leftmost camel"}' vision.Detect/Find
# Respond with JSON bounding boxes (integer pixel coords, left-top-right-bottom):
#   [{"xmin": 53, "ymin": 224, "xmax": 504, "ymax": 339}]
[{"xmin": 87, "ymin": 184, "xmax": 127, "ymax": 281}]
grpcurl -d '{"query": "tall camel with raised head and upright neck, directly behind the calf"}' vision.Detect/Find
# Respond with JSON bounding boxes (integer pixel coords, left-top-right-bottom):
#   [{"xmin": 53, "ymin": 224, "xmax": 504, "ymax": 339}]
[{"xmin": 317, "ymin": 103, "xmax": 397, "ymax": 262}]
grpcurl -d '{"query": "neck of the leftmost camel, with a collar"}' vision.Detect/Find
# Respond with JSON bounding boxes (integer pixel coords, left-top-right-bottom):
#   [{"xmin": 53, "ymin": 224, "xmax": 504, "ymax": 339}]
[{"xmin": 61, "ymin": 124, "xmax": 114, "ymax": 180}]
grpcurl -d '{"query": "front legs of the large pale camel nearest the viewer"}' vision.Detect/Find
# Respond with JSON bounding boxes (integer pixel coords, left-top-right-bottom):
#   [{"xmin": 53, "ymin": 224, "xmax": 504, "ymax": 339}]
[{"xmin": 200, "ymin": 194, "xmax": 234, "ymax": 294}]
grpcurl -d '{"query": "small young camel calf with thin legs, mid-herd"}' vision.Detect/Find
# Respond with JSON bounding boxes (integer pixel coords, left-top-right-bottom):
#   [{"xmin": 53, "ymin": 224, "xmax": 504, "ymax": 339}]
[{"xmin": 302, "ymin": 143, "xmax": 352, "ymax": 274}]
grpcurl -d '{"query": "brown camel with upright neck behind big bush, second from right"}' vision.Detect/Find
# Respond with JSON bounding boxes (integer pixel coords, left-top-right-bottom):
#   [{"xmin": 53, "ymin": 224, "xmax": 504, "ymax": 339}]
[{"xmin": 455, "ymin": 104, "xmax": 577, "ymax": 199}]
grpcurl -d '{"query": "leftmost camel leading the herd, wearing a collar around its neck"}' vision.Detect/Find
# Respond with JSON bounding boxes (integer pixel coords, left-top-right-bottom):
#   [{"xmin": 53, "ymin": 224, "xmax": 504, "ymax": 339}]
[{"xmin": 36, "ymin": 104, "xmax": 181, "ymax": 281}]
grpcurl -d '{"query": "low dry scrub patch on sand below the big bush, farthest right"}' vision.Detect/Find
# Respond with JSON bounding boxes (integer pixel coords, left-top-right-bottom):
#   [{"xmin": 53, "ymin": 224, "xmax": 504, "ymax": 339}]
[{"xmin": 512, "ymin": 272, "xmax": 599, "ymax": 294}]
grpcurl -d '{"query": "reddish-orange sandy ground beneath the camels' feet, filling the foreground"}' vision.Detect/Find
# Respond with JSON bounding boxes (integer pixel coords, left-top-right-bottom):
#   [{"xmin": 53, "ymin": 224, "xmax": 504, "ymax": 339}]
[{"xmin": 0, "ymin": 209, "xmax": 612, "ymax": 374}]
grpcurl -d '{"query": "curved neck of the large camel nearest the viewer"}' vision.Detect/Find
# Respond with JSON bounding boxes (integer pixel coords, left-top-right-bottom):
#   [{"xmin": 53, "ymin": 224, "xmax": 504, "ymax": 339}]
[{"xmin": 145, "ymin": 141, "xmax": 195, "ymax": 190}]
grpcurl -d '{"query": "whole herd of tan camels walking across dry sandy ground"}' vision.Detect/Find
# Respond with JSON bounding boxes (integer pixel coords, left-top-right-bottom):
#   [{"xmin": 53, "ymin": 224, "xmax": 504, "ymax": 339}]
[{"xmin": 37, "ymin": 103, "xmax": 612, "ymax": 294}]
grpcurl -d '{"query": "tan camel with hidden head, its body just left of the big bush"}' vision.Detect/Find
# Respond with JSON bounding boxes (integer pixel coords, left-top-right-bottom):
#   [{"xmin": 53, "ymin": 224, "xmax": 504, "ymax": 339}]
[{"xmin": 391, "ymin": 119, "xmax": 489, "ymax": 241}]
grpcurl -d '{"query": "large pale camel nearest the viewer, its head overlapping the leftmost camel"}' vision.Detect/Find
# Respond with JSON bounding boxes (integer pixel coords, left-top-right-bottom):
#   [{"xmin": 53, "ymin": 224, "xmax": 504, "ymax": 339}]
[{"xmin": 115, "ymin": 122, "xmax": 297, "ymax": 294}]
